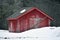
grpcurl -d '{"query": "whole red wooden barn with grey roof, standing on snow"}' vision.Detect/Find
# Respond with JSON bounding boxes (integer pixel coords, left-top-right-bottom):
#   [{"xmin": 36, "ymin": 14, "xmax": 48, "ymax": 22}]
[{"xmin": 7, "ymin": 7, "xmax": 53, "ymax": 32}]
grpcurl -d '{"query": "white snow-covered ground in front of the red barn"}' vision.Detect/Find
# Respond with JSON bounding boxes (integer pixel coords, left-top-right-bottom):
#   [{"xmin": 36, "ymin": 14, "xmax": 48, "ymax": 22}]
[{"xmin": 0, "ymin": 27, "xmax": 60, "ymax": 40}]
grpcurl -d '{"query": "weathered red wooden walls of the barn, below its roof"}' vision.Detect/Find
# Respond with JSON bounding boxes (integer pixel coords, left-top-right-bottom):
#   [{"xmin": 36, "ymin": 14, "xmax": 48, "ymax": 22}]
[{"xmin": 8, "ymin": 9, "xmax": 50, "ymax": 32}]
